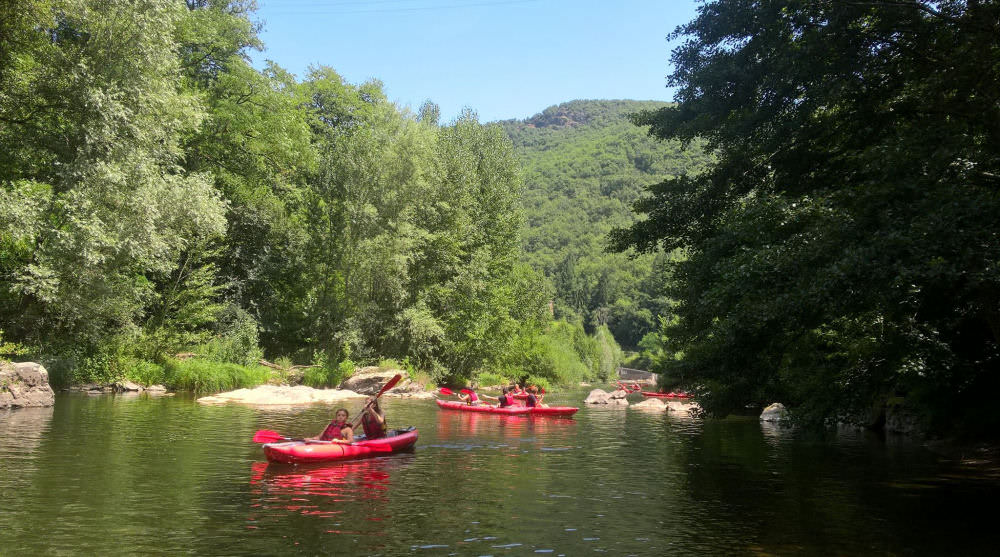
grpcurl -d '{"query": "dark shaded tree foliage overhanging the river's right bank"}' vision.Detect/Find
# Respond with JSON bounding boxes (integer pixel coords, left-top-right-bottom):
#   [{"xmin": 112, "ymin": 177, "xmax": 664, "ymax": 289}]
[{"xmin": 614, "ymin": 0, "xmax": 1000, "ymax": 432}]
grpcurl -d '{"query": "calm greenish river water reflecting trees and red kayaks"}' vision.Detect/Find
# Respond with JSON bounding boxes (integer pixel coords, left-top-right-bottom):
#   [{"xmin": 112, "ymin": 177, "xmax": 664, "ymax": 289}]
[{"xmin": 0, "ymin": 390, "xmax": 1000, "ymax": 555}]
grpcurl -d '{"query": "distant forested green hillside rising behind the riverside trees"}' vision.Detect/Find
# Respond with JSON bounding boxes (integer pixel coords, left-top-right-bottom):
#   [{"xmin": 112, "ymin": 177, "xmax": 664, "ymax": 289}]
[{"xmin": 502, "ymin": 100, "xmax": 707, "ymax": 348}]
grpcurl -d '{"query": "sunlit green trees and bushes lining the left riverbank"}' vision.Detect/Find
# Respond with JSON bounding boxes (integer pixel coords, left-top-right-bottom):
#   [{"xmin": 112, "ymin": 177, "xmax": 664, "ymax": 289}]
[{"xmin": 0, "ymin": 0, "xmax": 617, "ymax": 390}]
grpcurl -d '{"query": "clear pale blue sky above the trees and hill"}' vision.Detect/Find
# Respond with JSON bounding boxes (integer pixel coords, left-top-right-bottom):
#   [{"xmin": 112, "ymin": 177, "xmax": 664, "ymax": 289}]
[{"xmin": 254, "ymin": 0, "xmax": 696, "ymax": 122}]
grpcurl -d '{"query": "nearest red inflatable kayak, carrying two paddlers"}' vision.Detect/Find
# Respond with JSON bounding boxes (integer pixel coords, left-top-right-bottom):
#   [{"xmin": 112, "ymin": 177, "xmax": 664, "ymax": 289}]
[{"xmin": 264, "ymin": 427, "xmax": 417, "ymax": 464}]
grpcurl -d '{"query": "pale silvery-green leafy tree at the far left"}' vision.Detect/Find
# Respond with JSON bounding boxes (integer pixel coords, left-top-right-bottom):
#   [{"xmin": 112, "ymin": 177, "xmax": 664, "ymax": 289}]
[{"xmin": 0, "ymin": 0, "xmax": 225, "ymax": 362}]
